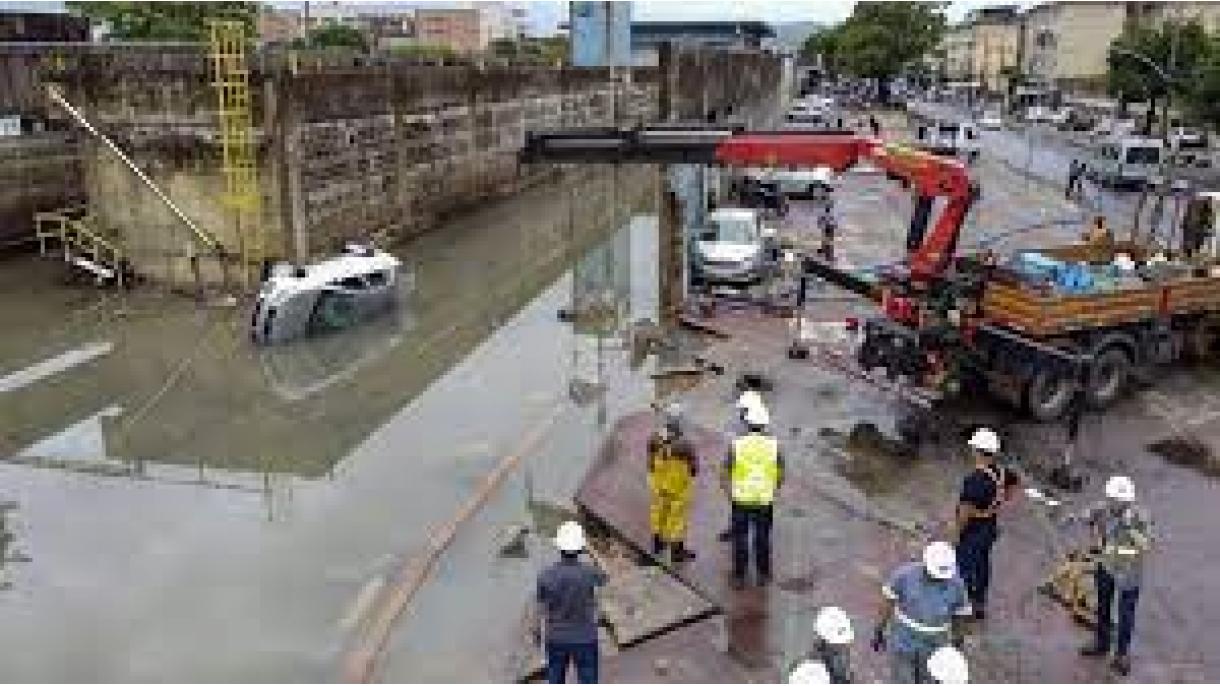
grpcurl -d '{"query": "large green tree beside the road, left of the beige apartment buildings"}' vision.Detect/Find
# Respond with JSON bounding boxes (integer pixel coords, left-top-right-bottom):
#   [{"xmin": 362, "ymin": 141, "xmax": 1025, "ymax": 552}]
[{"xmin": 832, "ymin": 1, "xmax": 946, "ymax": 103}]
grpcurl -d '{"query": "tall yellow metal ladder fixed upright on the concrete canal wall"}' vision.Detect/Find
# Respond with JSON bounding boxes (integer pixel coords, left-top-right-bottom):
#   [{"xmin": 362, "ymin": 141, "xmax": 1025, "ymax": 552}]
[{"xmin": 210, "ymin": 21, "xmax": 265, "ymax": 276}]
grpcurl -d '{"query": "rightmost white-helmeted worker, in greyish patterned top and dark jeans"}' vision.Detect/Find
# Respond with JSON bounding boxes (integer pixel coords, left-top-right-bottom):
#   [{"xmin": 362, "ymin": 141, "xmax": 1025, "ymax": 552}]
[{"xmin": 1081, "ymin": 475, "xmax": 1152, "ymax": 676}]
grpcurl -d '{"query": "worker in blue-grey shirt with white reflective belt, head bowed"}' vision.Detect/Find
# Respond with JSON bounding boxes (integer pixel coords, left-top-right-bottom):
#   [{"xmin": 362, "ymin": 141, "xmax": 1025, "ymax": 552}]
[{"xmin": 872, "ymin": 541, "xmax": 971, "ymax": 684}]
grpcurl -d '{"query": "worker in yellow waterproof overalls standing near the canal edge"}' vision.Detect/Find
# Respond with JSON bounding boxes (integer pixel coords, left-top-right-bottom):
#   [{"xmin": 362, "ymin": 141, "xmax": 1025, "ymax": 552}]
[{"xmin": 648, "ymin": 404, "xmax": 699, "ymax": 563}]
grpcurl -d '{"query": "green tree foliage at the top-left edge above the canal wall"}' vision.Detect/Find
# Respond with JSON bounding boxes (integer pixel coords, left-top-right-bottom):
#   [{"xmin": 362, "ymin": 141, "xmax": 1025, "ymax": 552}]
[{"xmin": 67, "ymin": 2, "xmax": 259, "ymax": 42}]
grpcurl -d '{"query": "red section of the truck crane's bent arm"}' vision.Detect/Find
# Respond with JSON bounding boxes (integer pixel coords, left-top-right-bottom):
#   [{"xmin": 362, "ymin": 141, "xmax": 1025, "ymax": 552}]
[{"xmin": 715, "ymin": 133, "xmax": 974, "ymax": 280}]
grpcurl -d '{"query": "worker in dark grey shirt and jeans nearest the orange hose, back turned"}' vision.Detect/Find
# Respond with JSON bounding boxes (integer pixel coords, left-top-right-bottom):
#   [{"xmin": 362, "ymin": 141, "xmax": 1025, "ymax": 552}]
[{"xmin": 536, "ymin": 521, "xmax": 606, "ymax": 684}]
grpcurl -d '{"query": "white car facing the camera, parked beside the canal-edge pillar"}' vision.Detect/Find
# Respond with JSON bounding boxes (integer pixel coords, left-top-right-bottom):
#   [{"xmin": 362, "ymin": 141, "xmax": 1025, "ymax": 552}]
[{"xmin": 691, "ymin": 208, "xmax": 765, "ymax": 286}]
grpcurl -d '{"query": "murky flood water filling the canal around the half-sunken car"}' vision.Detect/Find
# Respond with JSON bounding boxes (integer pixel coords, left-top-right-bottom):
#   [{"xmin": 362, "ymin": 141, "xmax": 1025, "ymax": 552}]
[{"xmin": 0, "ymin": 168, "xmax": 678, "ymax": 681}]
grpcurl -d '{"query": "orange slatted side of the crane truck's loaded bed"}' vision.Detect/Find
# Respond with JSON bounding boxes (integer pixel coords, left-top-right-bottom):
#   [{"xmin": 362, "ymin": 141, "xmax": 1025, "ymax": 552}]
[{"xmin": 982, "ymin": 244, "xmax": 1220, "ymax": 338}]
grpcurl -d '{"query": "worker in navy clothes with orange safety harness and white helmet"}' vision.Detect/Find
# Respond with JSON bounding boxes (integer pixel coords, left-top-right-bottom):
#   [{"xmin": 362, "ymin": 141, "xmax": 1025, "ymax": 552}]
[{"xmin": 955, "ymin": 427, "xmax": 1020, "ymax": 619}]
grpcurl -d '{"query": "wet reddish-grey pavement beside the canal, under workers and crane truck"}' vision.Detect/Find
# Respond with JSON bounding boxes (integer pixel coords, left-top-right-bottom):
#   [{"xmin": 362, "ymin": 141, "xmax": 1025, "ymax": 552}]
[{"xmin": 563, "ymin": 109, "xmax": 1220, "ymax": 682}]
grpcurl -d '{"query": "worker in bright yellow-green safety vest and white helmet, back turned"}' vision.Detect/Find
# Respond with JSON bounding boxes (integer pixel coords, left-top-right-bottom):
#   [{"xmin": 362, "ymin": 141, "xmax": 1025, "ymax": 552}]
[{"xmin": 723, "ymin": 405, "xmax": 783, "ymax": 588}]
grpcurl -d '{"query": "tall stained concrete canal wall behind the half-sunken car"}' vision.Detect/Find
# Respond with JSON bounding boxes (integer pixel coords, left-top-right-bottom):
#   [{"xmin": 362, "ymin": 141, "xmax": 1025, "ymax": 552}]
[{"xmin": 0, "ymin": 45, "xmax": 780, "ymax": 286}]
